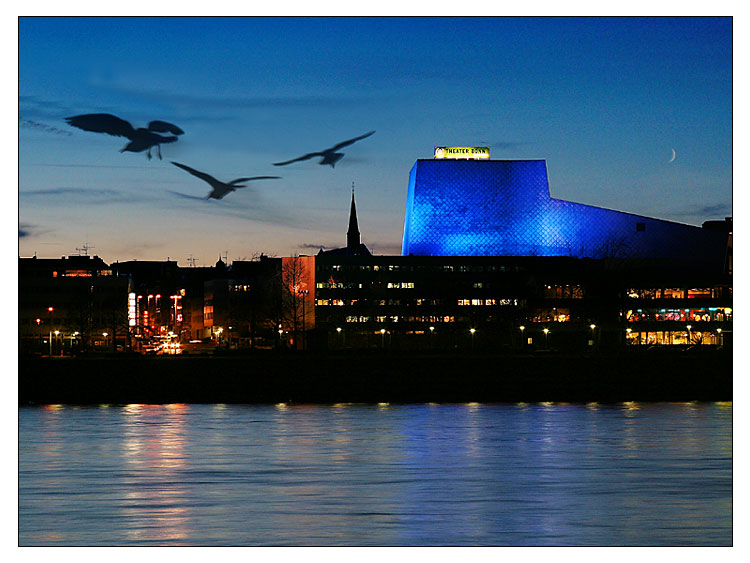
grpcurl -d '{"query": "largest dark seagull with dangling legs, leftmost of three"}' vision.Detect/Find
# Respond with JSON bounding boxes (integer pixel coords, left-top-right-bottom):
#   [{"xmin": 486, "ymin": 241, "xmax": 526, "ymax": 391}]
[{"xmin": 65, "ymin": 113, "xmax": 184, "ymax": 160}]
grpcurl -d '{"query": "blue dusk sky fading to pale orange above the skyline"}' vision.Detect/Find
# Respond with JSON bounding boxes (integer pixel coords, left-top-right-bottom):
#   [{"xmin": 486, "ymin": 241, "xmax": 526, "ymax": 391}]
[{"xmin": 18, "ymin": 18, "xmax": 732, "ymax": 266}]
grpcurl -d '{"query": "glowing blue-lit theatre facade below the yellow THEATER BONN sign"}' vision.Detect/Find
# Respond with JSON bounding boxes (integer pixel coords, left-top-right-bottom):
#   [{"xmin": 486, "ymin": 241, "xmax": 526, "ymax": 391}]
[{"xmin": 402, "ymin": 160, "xmax": 727, "ymax": 262}]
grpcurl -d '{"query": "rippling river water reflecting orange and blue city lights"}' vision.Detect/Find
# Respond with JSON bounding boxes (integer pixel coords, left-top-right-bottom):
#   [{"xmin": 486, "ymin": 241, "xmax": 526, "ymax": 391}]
[{"xmin": 18, "ymin": 403, "xmax": 732, "ymax": 546}]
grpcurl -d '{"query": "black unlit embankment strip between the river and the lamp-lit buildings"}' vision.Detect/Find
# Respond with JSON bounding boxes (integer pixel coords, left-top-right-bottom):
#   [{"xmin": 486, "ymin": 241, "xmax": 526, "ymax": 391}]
[{"xmin": 19, "ymin": 351, "xmax": 732, "ymax": 404}]
